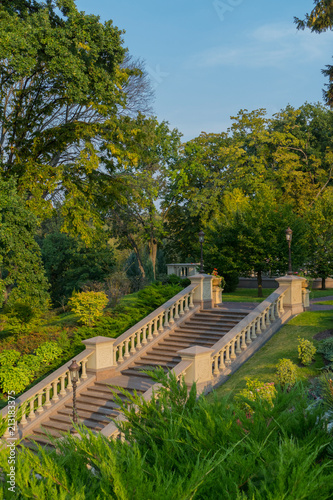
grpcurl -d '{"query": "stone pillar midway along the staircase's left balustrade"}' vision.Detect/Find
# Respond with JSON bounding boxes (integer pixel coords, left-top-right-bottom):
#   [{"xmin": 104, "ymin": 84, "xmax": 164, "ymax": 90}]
[{"xmin": 82, "ymin": 336, "xmax": 116, "ymax": 379}]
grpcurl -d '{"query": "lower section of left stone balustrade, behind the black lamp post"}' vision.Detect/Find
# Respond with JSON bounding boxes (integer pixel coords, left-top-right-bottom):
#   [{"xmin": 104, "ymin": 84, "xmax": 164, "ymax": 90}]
[{"xmin": 1, "ymin": 349, "xmax": 93, "ymax": 438}]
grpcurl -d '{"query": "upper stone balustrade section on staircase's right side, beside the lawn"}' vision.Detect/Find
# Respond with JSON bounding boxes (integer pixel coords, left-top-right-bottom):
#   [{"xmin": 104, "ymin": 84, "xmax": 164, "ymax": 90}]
[{"xmin": 211, "ymin": 286, "xmax": 288, "ymax": 377}]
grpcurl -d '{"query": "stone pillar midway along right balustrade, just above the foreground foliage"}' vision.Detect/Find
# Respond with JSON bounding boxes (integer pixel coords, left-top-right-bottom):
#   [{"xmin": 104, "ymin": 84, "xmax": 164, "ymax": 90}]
[{"xmin": 177, "ymin": 345, "xmax": 214, "ymax": 393}]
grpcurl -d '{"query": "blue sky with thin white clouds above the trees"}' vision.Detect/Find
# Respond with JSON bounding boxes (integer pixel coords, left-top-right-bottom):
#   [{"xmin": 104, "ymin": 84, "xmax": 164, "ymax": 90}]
[{"xmin": 76, "ymin": 0, "xmax": 333, "ymax": 140}]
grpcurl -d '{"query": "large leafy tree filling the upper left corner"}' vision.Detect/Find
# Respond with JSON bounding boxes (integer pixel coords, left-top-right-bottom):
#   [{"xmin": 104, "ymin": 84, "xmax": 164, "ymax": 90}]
[{"xmin": 0, "ymin": 0, "xmax": 133, "ymax": 242}]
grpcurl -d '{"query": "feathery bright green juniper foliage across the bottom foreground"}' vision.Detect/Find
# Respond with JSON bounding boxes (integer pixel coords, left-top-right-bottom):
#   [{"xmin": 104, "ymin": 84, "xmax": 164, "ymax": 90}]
[{"xmin": 0, "ymin": 371, "xmax": 333, "ymax": 500}]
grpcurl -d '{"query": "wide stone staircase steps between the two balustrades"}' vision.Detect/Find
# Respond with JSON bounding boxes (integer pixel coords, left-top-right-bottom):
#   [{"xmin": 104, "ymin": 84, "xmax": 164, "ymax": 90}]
[{"xmin": 22, "ymin": 308, "xmax": 248, "ymax": 446}]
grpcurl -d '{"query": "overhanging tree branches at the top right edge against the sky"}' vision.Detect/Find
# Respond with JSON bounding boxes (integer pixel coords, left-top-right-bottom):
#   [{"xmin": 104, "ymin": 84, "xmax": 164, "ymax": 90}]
[{"xmin": 295, "ymin": 0, "xmax": 333, "ymax": 107}]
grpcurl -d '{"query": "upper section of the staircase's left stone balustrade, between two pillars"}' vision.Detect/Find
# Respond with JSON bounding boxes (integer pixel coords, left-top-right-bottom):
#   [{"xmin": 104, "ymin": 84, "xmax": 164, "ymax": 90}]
[{"xmin": 113, "ymin": 284, "xmax": 198, "ymax": 366}]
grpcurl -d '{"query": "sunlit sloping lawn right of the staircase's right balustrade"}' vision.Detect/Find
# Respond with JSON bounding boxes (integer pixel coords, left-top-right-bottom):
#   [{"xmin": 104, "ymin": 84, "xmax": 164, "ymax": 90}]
[{"xmin": 208, "ymin": 311, "xmax": 333, "ymax": 397}]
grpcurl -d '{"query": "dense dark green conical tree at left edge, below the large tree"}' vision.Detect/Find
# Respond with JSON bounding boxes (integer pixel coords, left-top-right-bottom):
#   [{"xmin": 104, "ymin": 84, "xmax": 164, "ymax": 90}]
[{"xmin": 0, "ymin": 180, "xmax": 49, "ymax": 310}]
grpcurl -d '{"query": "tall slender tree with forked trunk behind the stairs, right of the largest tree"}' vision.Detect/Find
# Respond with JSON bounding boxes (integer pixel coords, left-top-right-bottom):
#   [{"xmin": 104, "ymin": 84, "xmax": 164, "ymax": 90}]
[{"xmin": 104, "ymin": 114, "xmax": 180, "ymax": 277}]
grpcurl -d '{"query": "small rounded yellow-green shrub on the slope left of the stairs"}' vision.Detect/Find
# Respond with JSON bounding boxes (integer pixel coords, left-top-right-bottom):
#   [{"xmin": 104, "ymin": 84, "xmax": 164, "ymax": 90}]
[{"xmin": 68, "ymin": 292, "xmax": 108, "ymax": 326}]
